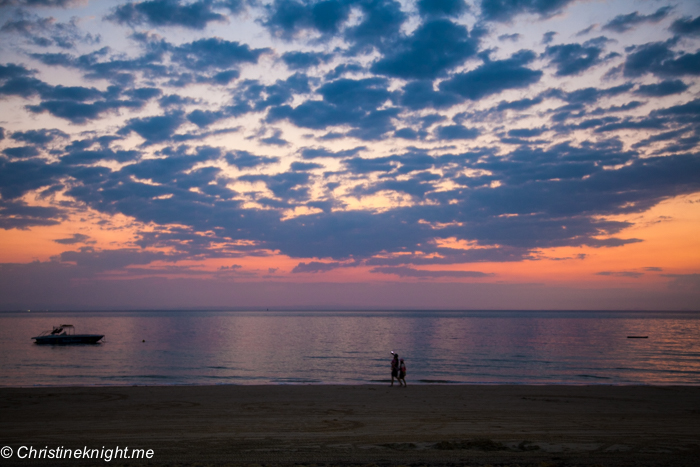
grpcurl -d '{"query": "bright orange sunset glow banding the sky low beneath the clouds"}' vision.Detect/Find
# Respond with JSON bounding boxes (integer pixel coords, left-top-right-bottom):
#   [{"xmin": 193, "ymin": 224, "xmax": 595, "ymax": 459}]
[{"xmin": 0, "ymin": 194, "xmax": 700, "ymax": 287}]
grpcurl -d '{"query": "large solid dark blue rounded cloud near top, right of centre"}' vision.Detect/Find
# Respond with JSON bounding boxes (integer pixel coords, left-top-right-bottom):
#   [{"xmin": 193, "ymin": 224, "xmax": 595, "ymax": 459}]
[{"xmin": 371, "ymin": 19, "xmax": 478, "ymax": 79}]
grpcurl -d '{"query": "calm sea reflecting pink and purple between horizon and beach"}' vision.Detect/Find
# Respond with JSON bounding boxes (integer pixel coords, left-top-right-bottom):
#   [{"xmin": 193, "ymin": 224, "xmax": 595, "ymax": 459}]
[{"xmin": 0, "ymin": 311, "xmax": 700, "ymax": 386}]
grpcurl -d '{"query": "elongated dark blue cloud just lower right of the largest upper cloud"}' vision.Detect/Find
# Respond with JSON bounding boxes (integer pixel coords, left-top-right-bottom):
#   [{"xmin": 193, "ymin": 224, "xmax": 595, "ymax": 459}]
[{"xmin": 440, "ymin": 50, "xmax": 542, "ymax": 100}]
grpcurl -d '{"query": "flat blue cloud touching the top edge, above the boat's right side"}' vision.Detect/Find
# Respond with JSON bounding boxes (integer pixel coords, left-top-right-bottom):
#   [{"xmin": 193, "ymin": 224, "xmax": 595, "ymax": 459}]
[{"xmin": 105, "ymin": 0, "xmax": 226, "ymax": 29}]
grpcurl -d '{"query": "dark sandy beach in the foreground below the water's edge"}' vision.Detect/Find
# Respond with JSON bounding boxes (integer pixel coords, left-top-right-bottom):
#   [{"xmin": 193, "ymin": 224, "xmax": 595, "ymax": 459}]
[{"xmin": 0, "ymin": 385, "xmax": 700, "ymax": 467}]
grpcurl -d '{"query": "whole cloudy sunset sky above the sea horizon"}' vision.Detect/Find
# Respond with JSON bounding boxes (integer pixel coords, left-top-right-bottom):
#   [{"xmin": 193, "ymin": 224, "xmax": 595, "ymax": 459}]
[{"xmin": 0, "ymin": 0, "xmax": 700, "ymax": 310}]
